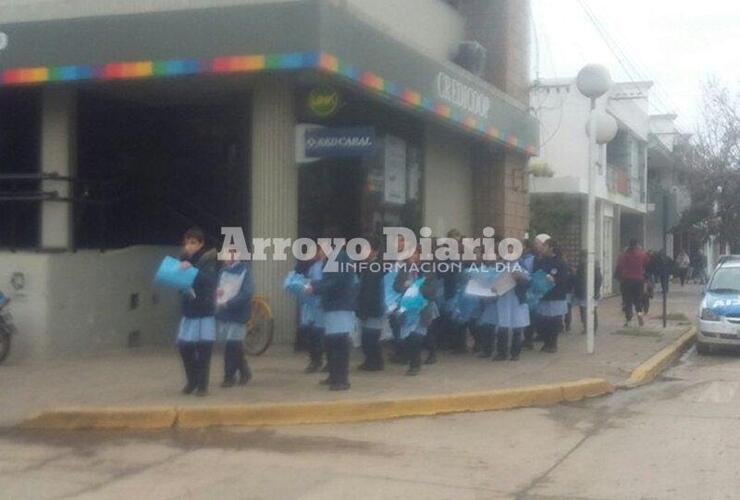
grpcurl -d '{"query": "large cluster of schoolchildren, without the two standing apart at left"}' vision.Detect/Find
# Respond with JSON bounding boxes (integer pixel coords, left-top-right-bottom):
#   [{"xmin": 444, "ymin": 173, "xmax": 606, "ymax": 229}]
[{"xmin": 284, "ymin": 232, "xmax": 572, "ymax": 390}]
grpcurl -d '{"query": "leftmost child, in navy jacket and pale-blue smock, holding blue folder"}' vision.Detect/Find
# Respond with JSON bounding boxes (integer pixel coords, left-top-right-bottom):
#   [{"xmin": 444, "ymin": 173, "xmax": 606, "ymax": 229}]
[{"xmin": 177, "ymin": 227, "xmax": 218, "ymax": 396}]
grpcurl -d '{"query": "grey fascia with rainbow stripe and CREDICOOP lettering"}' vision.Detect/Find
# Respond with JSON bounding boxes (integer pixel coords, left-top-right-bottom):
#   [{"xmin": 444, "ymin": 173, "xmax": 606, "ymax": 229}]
[{"xmin": 0, "ymin": 0, "xmax": 539, "ymax": 155}]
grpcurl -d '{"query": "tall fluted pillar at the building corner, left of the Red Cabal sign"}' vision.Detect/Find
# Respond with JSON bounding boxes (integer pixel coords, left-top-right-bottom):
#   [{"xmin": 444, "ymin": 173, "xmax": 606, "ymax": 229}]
[{"xmin": 251, "ymin": 79, "xmax": 298, "ymax": 342}]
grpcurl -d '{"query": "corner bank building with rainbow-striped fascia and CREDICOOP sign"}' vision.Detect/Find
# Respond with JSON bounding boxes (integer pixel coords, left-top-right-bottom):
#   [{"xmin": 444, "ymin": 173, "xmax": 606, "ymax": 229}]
[{"xmin": 0, "ymin": 0, "xmax": 539, "ymax": 358}]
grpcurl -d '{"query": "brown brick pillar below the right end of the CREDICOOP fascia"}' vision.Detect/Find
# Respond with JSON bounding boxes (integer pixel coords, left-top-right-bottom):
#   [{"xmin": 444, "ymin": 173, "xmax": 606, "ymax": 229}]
[{"xmin": 473, "ymin": 150, "xmax": 529, "ymax": 238}]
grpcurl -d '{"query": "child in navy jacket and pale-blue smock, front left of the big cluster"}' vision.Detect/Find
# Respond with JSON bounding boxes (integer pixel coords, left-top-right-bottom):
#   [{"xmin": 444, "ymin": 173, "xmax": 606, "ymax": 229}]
[{"xmin": 307, "ymin": 230, "xmax": 359, "ymax": 391}]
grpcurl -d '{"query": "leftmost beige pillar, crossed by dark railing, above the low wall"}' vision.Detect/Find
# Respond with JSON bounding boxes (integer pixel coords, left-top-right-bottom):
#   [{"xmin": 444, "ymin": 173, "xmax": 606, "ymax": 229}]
[{"xmin": 40, "ymin": 87, "xmax": 77, "ymax": 250}]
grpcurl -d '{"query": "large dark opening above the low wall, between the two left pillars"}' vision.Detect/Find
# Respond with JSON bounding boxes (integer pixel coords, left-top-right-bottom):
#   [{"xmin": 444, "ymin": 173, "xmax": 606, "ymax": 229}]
[{"xmin": 74, "ymin": 81, "xmax": 250, "ymax": 248}]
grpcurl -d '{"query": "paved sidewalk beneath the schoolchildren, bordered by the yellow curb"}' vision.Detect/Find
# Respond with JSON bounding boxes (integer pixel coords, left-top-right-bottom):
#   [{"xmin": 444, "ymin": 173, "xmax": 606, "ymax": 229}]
[{"xmin": 0, "ymin": 286, "xmax": 700, "ymax": 427}]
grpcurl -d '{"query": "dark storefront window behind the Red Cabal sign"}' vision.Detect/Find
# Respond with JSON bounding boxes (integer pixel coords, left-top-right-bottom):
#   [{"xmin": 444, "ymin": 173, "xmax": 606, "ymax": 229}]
[{"xmin": 298, "ymin": 83, "xmax": 424, "ymax": 238}]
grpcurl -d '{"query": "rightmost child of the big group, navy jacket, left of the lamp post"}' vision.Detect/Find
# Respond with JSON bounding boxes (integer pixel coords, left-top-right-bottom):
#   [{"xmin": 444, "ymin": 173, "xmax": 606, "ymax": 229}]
[{"xmin": 535, "ymin": 238, "xmax": 570, "ymax": 353}]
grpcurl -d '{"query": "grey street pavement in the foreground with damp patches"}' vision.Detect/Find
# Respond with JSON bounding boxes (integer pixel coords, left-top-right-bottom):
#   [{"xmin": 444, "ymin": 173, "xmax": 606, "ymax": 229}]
[{"xmin": 0, "ymin": 344, "xmax": 740, "ymax": 500}]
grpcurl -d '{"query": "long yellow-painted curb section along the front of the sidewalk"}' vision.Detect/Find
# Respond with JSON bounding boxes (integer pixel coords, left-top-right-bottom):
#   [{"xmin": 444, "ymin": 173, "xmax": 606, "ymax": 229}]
[{"xmin": 21, "ymin": 379, "xmax": 615, "ymax": 430}]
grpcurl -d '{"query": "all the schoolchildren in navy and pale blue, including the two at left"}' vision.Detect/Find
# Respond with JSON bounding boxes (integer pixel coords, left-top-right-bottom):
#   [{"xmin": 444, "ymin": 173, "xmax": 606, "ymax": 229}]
[{"xmin": 177, "ymin": 228, "xmax": 588, "ymax": 396}]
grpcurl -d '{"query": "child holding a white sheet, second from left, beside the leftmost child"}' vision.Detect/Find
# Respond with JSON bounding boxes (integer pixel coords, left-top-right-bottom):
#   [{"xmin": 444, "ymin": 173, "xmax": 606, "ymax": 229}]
[{"xmin": 216, "ymin": 254, "xmax": 254, "ymax": 388}]
